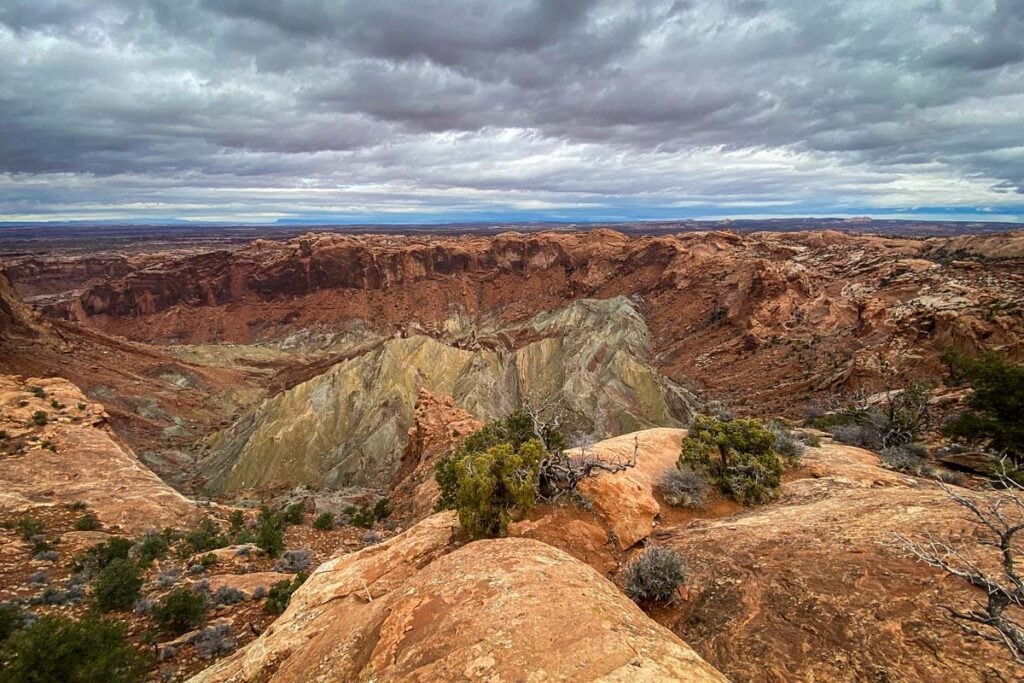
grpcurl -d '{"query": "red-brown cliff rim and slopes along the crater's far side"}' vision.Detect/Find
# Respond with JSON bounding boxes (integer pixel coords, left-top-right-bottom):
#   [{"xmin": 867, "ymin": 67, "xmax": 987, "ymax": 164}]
[{"xmin": 37, "ymin": 230, "xmax": 1024, "ymax": 412}]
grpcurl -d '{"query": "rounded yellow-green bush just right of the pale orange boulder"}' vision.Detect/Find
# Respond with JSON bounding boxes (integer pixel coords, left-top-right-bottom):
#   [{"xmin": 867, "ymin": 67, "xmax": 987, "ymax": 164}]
[{"xmin": 679, "ymin": 416, "xmax": 782, "ymax": 505}]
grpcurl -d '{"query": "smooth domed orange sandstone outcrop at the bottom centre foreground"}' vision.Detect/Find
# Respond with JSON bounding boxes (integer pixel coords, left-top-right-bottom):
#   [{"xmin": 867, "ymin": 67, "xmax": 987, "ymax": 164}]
[{"xmin": 193, "ymin": 513, "xmax": 725, "ymax": 682}]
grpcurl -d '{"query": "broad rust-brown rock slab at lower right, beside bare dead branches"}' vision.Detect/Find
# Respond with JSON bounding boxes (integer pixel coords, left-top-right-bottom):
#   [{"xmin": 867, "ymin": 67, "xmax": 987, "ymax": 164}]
[{"xmin": 655, "ymin": 444, "xmax": 1020, "ymax": 682}]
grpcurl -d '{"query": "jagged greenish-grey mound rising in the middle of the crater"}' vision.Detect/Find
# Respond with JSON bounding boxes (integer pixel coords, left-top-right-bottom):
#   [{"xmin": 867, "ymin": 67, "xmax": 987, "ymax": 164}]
[{"xmin": 201, "ymin": 297, "xmax": 696, "ymax": 490}]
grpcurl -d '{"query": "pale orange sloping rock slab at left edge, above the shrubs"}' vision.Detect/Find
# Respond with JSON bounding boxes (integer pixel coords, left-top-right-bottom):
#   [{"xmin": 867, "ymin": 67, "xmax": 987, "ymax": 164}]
[{"xmin": 0, "ymin": 375, "xmax": 197, "ymax": 535}]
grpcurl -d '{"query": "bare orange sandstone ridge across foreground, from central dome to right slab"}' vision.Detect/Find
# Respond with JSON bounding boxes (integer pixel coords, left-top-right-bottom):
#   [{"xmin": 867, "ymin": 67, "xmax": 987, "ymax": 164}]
[{"xmin": 182, "ymin": 417, "xmax": 1014, "ymax": 682}]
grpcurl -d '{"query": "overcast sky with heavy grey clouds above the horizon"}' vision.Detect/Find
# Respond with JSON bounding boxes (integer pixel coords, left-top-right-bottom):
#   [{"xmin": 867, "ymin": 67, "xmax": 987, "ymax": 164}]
[{"xmin": 0, "ymin": 0, "xmax": 1024, "ymax": 222}]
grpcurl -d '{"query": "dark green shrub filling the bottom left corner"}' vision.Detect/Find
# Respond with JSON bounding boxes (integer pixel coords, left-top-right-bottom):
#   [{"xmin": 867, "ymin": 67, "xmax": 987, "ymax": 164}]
[{"xmin": 0, "ymin": 613, "xmax": 148, "ymax": 683}]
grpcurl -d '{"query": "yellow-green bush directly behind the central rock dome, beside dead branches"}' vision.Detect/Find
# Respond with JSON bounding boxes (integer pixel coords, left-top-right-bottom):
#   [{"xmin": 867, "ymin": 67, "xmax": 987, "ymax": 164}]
[{"xmin": 435, "ymin": 439, "xmax": 546, "ymax": 539}]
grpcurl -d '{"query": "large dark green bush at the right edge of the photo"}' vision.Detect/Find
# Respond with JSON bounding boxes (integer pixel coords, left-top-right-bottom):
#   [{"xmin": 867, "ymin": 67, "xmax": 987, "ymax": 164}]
[{"xmin": 942, "ymin": 351, "xmax": 1024, "ymax": 467}]
